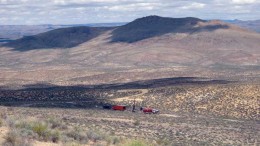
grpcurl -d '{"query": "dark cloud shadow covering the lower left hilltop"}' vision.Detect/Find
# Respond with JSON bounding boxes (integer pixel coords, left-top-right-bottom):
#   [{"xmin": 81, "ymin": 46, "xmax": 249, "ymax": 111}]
[{"xmin": 2, "ymin": 26, "xmax": 112, "ymax": 52}]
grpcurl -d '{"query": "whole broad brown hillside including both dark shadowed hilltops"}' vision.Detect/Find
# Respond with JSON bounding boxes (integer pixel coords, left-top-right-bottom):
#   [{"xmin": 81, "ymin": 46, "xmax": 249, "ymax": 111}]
[{"xmin": 0, "ymin": 16, "xmax": 260, "ymax": 85}]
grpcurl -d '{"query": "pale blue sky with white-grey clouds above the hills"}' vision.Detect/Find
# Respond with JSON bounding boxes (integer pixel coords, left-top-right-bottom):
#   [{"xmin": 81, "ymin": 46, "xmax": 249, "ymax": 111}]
[{"xmin": 0, "ymin": 0, "xmax": 260, "ymax": 25}]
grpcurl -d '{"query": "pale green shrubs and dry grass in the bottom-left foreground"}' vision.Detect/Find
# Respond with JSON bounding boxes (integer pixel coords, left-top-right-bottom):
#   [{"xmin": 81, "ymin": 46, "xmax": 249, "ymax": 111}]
[{"xmin": 0, "ymin": 116, "xmax": 144, "ymax": 146}]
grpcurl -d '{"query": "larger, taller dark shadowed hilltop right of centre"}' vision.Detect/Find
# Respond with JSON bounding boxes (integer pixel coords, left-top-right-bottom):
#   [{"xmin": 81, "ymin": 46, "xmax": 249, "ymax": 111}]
[{"xmin": 112, "ymin": 16, "xmax": 205, "ymax": 43}]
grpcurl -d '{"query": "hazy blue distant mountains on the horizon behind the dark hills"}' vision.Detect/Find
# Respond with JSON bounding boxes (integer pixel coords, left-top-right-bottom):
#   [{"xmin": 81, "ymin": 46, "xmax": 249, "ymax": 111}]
[{"xmin": 0, "ymin": 18, "xmax": 260, "ymax": 44}]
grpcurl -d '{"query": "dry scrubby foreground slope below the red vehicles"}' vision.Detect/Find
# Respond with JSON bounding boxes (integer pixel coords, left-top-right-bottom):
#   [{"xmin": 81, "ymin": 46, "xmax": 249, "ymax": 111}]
[{"xmin": 0, "ymin": 103, "xmax": 260, "ymax": 146}]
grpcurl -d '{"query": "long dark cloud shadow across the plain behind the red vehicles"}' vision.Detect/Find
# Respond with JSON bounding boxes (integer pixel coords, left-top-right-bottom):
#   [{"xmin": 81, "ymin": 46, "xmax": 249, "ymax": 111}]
[{"xmin": 0, "ymin": 77, "xmax": 230, "ymax": 108}]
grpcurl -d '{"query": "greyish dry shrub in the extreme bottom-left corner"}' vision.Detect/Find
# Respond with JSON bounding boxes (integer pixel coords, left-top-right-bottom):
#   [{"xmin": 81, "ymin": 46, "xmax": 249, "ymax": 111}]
[{"xmin": 3, "ymin": 129, "xmax": 32, "ymax": 146}]
